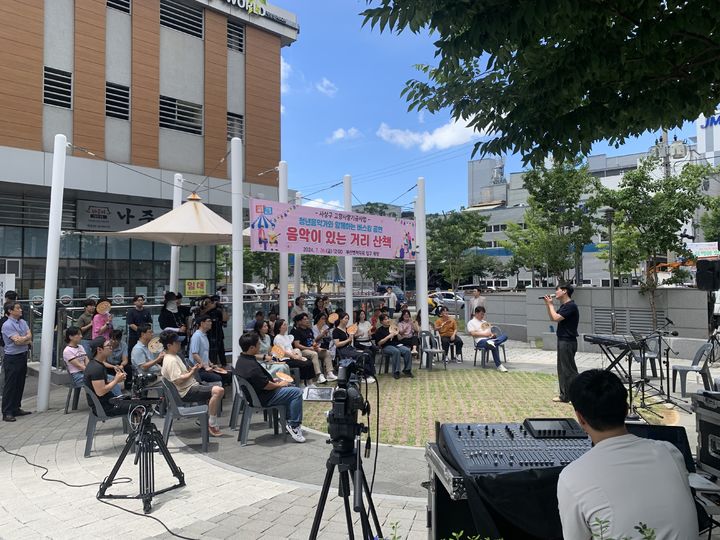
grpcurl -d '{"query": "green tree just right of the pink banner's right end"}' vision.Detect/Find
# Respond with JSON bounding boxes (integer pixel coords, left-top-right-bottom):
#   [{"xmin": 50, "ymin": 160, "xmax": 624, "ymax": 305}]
[{"xmin": 427, "ymin": 211, "xmax": 487, "ymax": 290}]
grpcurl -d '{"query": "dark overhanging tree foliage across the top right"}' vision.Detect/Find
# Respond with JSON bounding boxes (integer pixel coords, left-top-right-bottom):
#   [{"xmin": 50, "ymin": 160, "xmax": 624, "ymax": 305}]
[{"xmin": 363, "ymin": 0, "xmax": 720, "ymax": 164}]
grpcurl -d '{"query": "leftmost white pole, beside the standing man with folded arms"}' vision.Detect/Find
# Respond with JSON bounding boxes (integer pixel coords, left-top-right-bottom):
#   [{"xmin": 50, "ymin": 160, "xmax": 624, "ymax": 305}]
[{"xmin": 37, "ymin": 134, "xmax": 67, "ymax": 411}]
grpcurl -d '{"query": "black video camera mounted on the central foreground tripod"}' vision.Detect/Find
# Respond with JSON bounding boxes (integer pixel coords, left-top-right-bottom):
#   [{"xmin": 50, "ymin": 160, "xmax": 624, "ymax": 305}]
[{"xmin": 328, "ymin": 360, "xmax": 370, "ymax": 451}]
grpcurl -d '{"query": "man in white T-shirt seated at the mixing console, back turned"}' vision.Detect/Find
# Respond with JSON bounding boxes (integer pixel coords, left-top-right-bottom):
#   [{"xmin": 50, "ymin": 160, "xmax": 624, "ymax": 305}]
[{"xmin": 557, "ymin": 369, "xmax": 698, "ymax": 540}]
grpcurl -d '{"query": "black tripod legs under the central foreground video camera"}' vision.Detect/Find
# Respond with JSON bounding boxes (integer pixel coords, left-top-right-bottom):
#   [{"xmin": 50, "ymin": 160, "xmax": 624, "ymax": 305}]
[{"xmin": 310, "ymin": 435, "xmax": 383, "ymax": 540}]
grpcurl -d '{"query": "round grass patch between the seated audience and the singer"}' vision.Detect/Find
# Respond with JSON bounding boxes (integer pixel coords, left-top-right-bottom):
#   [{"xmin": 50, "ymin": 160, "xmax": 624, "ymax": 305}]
[{"xmin": 303, "ymin": 368, "xmax": 574, "ymax": 446}]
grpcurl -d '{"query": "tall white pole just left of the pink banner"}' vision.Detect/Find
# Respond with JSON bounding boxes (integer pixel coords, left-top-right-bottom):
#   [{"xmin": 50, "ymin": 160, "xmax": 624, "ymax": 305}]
[{"xmin": 230, "ymin": 137, "xmax": 244, "ymax": 365}]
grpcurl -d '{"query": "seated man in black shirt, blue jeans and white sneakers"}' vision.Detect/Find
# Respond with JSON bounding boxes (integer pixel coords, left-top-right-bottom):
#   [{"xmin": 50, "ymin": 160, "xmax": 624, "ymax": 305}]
[{"xmin": 234, "ymin": 332, "xmax": 305, "ymax": 443}]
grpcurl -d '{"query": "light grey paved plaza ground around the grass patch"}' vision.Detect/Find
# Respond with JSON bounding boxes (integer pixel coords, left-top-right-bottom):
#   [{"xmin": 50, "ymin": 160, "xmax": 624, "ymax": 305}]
[{"xmin": 0, "ymin": 337, "xmax": 716, "ymax": 540}]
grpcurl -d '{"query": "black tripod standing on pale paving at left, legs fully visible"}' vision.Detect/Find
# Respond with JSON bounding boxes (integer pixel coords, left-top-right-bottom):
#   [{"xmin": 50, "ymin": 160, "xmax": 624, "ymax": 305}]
[{"xmin": 97, "ymin": 399, "xmax": 185, "ymax": 514}]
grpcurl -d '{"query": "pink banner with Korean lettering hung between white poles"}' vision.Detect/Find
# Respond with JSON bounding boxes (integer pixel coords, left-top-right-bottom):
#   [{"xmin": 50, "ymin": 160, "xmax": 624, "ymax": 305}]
[{"xmin": 250, "ymin": 199, "xmax": 415, "ymax": 260}]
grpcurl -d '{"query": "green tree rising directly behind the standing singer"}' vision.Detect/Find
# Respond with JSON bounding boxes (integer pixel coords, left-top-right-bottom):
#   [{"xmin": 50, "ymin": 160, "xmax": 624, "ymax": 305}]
[{"xmin": 501, "ymin": 157, "xmax": 599, "ymax": 283}]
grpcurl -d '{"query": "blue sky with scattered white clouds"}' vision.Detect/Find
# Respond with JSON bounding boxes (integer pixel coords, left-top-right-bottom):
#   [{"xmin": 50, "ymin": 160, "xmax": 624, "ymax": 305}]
[{"xmin": 273, "ymin": 0, "xmax": 694, "ymax": 212}]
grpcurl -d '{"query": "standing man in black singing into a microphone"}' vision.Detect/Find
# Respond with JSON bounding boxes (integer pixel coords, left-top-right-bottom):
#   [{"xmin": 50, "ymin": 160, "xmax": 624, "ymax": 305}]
[{"xmin": 543, "ymin": 283, "xmax": 580, "ymax": 403}]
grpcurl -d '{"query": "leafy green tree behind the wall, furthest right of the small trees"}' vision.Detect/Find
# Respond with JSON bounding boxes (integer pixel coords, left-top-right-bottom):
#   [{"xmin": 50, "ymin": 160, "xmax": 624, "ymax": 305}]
[{"xmin": 601, "ymin": 159, "xmax": 712, "ymax": 328}]
